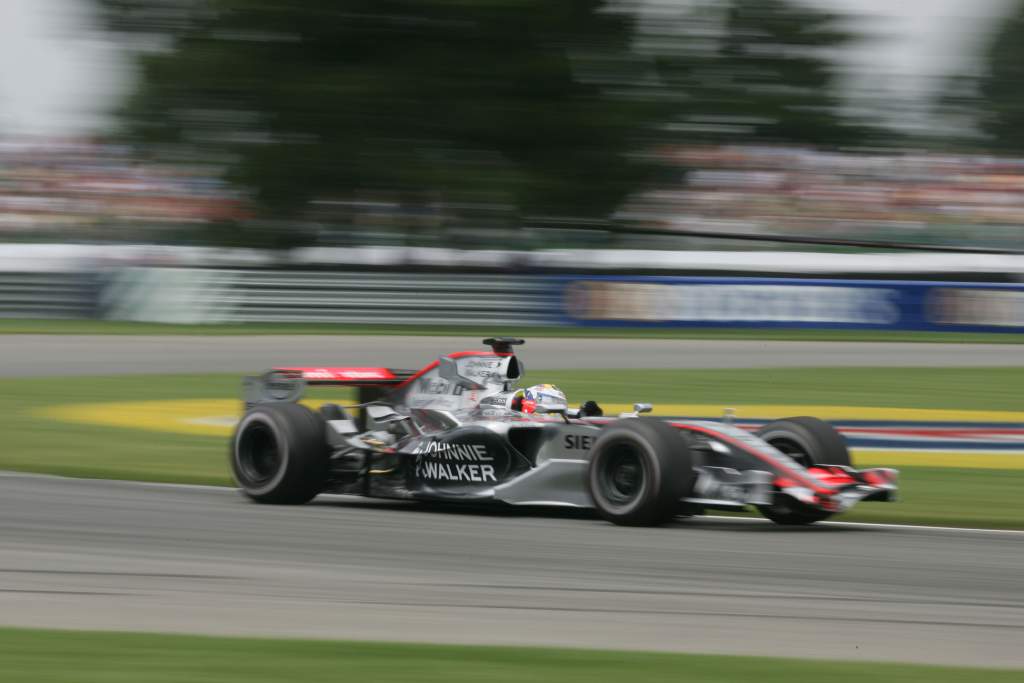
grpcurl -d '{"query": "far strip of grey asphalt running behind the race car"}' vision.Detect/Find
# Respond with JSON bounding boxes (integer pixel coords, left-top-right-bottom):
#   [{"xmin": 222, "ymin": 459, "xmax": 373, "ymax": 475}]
[{"xmin": 0, "ymin": 335, "xmax": 1024, "ymax": 377}]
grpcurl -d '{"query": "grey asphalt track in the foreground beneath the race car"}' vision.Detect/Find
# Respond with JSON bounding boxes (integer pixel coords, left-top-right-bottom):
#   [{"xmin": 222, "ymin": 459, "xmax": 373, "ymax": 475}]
[{"xmin": 0, "ymin": 474, "xmax": 1024, "ymax": 668}]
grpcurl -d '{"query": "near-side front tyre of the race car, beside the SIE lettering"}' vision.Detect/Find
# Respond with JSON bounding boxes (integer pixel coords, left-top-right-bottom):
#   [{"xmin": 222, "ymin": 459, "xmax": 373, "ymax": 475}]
[{"xmin": 587, "ymin": 418, "xmax": 696, "ymax": 526}]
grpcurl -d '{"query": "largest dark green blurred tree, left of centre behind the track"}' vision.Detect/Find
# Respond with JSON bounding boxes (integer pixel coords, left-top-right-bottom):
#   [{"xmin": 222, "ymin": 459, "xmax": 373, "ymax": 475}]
[{"xmin": 96, "ymin": 0, "xmax": 670, "ymax": 245}]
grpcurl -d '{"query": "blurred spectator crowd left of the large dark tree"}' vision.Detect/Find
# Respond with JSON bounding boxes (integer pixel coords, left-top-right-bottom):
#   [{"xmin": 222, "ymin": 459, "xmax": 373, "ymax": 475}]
[{"xmin": 0, "ymin": 139, "xmax": 244, "ymax": 242}]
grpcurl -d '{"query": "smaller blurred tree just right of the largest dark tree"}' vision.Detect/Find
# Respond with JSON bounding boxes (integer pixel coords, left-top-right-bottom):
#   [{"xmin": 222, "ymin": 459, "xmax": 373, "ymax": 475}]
[{"xmin": 647, "ymin": 0, "xmax": 868, "ymax": 146}]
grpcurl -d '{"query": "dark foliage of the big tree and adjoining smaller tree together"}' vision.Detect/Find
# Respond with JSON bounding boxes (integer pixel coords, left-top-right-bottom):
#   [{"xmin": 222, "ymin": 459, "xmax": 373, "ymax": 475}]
[{"xmin": 101, "ymin": 0, "xmax": 860, "ymax": 247}]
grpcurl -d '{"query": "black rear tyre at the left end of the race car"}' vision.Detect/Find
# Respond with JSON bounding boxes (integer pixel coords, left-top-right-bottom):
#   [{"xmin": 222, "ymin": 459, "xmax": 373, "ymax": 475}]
[{"xmin": 230, "ymin": 403, "xmax": 330, "ymax": 505}]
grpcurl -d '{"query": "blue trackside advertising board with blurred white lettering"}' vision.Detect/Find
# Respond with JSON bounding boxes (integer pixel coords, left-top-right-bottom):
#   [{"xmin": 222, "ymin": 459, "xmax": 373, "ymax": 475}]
[{"xmin": 557, "ymin": 275, "xmax": 1024, "ymax": 332}]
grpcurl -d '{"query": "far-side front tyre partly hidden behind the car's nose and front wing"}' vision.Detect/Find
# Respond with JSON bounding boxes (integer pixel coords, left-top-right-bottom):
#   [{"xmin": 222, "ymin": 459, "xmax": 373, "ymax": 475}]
[{"xmin": 757, "ymin": 417, "xmax": 853, "ymax": 526}]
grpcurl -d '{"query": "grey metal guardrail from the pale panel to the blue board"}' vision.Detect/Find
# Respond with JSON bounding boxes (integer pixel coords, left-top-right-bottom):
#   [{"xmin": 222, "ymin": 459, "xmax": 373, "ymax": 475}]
[{"xmin": 101, "ymin": 268, "xmax": 556, "ymax": 325}]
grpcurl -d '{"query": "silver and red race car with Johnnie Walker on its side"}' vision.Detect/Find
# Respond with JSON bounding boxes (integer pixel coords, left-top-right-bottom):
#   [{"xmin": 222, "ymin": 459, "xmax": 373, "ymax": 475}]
[{"xmin": 230, "ymin": 338, "xmax": 897, "ymax": 525}]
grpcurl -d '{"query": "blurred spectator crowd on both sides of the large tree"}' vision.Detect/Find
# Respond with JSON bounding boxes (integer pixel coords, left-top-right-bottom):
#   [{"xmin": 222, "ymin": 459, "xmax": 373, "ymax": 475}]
[{"xmin": 6, "ymin": 140, "xmax": 1024, "ymax": 249}]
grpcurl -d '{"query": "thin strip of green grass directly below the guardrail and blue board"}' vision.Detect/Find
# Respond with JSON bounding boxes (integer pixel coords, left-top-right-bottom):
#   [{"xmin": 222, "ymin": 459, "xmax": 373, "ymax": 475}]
[{"xmin": 0, "ymin": 319, "xmax": 1024, "ymax": 344}]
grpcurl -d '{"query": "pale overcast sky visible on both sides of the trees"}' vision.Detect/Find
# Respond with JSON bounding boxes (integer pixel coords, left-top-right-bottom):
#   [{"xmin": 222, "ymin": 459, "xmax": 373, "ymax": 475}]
[{"xmin": 0, "ymin": 0, "xmax": 1017, "ymax": 135}]
